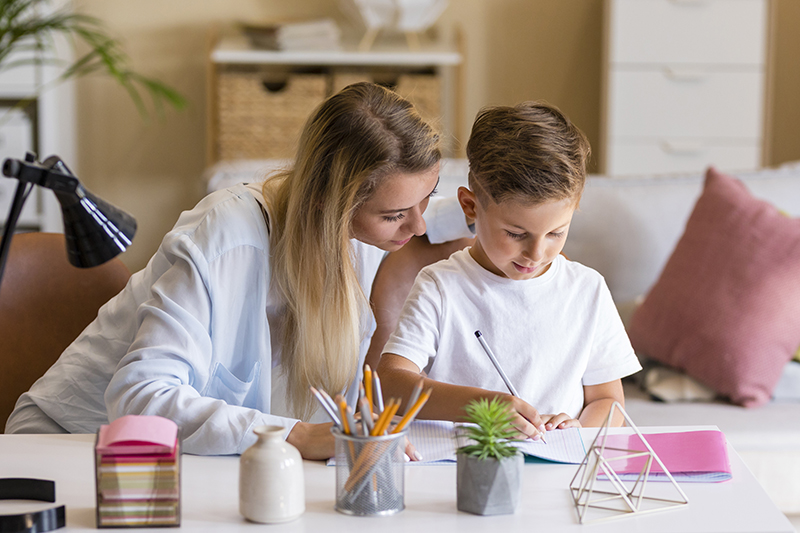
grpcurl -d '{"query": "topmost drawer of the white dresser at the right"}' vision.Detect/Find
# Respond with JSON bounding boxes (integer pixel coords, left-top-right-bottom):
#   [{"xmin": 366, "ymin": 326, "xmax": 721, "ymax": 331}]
[{"xmin": 609, "ymin": 0, "xmax": 767, "ymax": 65}]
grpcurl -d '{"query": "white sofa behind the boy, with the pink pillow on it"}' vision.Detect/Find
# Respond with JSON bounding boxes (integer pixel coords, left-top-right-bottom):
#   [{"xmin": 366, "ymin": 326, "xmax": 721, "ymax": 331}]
[{"xmin": 206, "ymin": 159, "xmax": 800, "ymax": 514}]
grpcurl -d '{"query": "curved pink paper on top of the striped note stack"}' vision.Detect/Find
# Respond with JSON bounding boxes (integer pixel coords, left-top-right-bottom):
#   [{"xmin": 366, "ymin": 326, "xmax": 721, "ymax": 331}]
[{"xmin": 97, "ymin": 415, "xmax": 178, "ymax": 455}]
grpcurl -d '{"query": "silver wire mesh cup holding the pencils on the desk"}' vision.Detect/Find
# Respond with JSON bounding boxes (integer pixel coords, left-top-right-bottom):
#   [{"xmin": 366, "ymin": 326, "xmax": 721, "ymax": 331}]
[{"xmin": 331, "ymin": 427, "xmax": 407, "ymax": 516}]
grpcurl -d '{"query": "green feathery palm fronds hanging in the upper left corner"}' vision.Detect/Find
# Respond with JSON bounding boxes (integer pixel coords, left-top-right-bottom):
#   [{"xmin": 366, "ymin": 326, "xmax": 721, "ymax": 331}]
[{"xmin": 0, "ymin": 0, "xmax": 186, "ymax": 116}]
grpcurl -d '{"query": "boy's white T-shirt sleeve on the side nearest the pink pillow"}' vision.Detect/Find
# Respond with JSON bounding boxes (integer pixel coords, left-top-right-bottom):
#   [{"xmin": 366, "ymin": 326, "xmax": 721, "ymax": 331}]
[{"xmin": 582, "ymin": 280, "xmax": 642, "ymax": 386}]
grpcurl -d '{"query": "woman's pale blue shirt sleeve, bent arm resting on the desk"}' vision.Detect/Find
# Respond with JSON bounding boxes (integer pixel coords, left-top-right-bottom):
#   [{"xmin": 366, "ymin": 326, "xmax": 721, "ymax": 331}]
[{"xmin": 105, "ymin": 235, "xmax": 297, "ymax": 455}]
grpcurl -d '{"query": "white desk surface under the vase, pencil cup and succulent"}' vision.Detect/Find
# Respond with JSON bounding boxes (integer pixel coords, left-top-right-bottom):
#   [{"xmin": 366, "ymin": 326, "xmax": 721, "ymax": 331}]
[{"xmin": 0, "ymin": 428, "xmax": 794, "ymax": 533}]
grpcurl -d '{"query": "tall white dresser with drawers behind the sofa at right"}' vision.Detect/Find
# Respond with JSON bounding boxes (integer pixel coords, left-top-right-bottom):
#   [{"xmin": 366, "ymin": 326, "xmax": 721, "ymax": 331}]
[{"xmin": 600, "ymin": 0, "xmax": 768, "ymax": 176}]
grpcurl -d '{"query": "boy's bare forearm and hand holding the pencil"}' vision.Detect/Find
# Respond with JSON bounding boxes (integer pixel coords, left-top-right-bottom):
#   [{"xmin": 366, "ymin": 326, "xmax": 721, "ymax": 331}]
[{"xmin": 378, "ymin": 353, "xmax": 544, "ymax": 437}]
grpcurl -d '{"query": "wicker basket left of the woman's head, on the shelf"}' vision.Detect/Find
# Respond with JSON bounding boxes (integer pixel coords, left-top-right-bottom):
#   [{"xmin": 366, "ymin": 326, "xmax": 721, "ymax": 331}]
[{"xmin": 217, "ymin": 71, "xmax": 327, "ymax": 160}]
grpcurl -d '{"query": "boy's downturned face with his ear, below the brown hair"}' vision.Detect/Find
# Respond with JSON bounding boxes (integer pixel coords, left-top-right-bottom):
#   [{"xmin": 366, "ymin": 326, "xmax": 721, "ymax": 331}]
[{"xmin": 458, "ymin": 187, "xmax": 577, "ymax": 280}]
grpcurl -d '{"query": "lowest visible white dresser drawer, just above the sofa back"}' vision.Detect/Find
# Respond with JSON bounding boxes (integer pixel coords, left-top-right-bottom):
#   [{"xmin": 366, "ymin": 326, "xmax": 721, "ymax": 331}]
[{"xmin": 606, "ymin": 140, "xmax": 761, "ymax": 176}]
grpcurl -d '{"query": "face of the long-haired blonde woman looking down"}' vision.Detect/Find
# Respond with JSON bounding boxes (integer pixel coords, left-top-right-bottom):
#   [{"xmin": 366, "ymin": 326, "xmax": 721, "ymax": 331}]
[{"xmin": 350, "ymin": 163, "xmax": 439, "ymax": 252}]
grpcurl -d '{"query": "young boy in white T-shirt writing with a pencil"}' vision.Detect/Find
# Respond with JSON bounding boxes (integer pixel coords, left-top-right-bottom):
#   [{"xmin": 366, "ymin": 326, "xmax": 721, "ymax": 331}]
[{"xmin": 378, "ymin": 102, "xmax": 641, "ymax": 439}]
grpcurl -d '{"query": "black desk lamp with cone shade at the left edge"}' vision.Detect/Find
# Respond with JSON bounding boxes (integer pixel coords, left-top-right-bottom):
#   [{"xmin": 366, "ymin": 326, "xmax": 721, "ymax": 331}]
[{"xmin": 0, "ymin": 152, "xmax": 136, "ymax": 281}]
